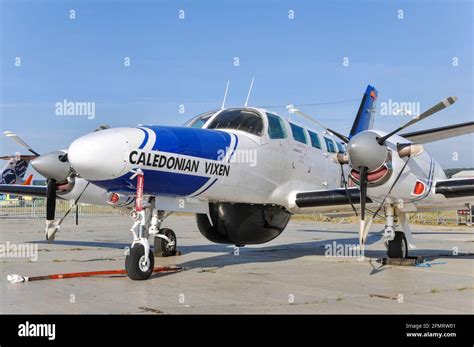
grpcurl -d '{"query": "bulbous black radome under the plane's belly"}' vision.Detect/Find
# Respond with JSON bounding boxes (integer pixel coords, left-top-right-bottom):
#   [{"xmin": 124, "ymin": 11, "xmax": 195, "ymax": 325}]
[{"xmin": 196, "ymin": 203, "xmax": 291, "ymax": 245}]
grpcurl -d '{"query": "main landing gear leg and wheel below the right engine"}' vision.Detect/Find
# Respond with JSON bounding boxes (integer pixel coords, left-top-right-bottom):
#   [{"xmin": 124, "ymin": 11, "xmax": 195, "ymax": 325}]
[{"xmin": 384, "ymin": 205, "xmax": 415, "ymax": 259}]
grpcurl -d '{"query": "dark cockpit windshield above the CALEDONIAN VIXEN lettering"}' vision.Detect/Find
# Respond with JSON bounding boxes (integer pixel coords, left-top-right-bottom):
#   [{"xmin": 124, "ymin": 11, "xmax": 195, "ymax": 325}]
[{"xmin": 207, "ymin": 109, "xmax": 263, "ymax": 136}]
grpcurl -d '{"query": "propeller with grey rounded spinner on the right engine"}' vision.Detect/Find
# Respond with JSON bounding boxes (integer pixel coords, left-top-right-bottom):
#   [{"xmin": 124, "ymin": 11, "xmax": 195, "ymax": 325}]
[{"xmin": 335, "ymin": 96, "xmax": 457, "ymax": 246}]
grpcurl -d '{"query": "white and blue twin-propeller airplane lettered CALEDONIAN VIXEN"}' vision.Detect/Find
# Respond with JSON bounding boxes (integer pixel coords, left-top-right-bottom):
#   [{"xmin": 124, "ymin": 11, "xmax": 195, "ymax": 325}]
[{"xmin": 0, "ymin": 85, "xmax": 474, "ymax": 280}]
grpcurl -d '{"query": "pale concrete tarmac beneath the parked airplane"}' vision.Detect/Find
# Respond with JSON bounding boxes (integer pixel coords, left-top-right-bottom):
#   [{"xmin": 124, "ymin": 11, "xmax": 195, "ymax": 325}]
[{"xmin": 0, "ymin": 216, "xmax": 474, "ymax": 314}]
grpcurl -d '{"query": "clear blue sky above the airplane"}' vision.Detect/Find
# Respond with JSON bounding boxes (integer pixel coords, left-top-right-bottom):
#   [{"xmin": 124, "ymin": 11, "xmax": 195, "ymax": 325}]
[{"xmin": 0, "ymin": 0, "xmax": 474, "ymax": 167}]
